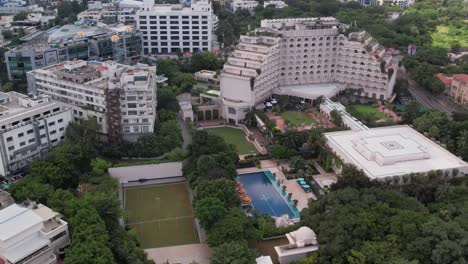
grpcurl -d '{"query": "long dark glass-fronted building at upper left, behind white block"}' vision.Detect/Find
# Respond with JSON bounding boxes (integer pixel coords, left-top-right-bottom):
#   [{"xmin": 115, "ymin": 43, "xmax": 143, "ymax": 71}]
[{"xmin": 5, "ymin": 23, "xmax": 142, "ymax": 80}]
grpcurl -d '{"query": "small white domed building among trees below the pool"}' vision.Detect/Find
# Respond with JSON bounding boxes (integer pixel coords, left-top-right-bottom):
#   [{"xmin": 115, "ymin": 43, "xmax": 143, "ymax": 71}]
[{"xmin": 275, "ymin": 226, "xmax": 319, "ymax": 264}]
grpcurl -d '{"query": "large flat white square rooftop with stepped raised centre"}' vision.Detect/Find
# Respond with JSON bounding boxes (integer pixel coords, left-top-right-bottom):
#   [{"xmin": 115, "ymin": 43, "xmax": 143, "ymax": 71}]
[{"xmin": 325, "ymin": 126, "xmax": 468, "ymax": 178}]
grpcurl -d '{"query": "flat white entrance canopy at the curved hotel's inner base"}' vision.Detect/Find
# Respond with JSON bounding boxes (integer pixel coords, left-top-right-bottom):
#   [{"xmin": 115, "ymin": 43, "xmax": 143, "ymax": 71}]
[{"xmin": 278, "ymin": 83, "xmax": 346, "ymax": 100}]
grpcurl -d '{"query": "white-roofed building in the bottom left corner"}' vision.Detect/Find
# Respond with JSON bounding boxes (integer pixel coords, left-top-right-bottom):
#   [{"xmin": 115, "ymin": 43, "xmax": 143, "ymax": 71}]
[{"xmin": 0, "ymin": 202, "xmax": 70, "ymax": 264}]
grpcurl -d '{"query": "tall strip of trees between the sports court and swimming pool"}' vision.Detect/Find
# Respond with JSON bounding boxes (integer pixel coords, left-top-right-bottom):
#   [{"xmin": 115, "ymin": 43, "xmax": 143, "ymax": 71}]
[{"xmin": 184, "ymin": 130, "xmax": 262, "ymax": 264}]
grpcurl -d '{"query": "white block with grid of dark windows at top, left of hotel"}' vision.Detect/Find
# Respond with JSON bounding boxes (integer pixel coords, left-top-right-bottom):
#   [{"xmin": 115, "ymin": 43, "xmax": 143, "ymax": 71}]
[{"xmin": 135, "ymin": 0, "xmax": 216, "ymax": 54}]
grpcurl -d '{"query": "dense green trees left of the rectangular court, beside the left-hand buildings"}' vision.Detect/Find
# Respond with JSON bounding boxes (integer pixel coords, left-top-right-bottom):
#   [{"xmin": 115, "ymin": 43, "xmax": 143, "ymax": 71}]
[{"xmin": 10, "ymin": 125, "xmax": 153, "ymax": 264}]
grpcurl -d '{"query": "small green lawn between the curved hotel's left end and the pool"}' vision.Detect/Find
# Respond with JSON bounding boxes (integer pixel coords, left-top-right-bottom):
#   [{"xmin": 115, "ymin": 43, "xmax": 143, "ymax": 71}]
[{"xmin": 206, "ymin": 127, "xmax": 257, "ymax": 154}]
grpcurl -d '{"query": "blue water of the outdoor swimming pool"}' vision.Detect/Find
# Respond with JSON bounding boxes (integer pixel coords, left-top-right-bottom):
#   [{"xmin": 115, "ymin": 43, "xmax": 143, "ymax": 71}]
[{"xmin": 237, "ymin": 172, "xmax": 300, "ymax": 219}]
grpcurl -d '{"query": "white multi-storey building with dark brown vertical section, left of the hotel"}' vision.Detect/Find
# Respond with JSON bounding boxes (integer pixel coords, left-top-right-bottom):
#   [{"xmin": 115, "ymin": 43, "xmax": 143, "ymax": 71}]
[{"xmin": 27, "ymin": 60, "xmax": 157, "ymax": 141}]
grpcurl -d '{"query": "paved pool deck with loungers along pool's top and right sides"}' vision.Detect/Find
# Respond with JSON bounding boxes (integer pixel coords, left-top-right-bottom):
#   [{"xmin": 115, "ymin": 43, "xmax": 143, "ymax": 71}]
[{"xmin": 237, "ymin": 160, "xmax": 317, "ymax": 211}]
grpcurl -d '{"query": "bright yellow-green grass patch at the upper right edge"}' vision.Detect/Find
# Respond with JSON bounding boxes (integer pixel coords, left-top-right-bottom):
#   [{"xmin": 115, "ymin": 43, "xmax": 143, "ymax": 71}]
[{"xmin": 432, "ymin": 23, "xmax": 468, "ymax": 49}]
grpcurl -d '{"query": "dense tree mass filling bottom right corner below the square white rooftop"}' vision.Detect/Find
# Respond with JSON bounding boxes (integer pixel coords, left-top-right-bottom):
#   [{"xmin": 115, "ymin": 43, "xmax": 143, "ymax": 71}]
[{"xmin": 301, "ymin": 169, "xmax": 468, "ymax": 264}]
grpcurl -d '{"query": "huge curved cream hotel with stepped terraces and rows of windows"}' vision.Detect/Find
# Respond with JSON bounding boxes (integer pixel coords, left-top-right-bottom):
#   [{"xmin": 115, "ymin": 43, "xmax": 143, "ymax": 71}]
[{"xmin": 220, "ymin": 17, "xmax": 397, "ymax": 122}]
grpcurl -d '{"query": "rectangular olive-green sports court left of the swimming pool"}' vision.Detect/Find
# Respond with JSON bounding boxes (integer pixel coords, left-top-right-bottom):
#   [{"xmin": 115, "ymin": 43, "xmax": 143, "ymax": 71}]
[{"xmin": 125, "ymin": 182, "xmax": 199, "ymax": 248}]
